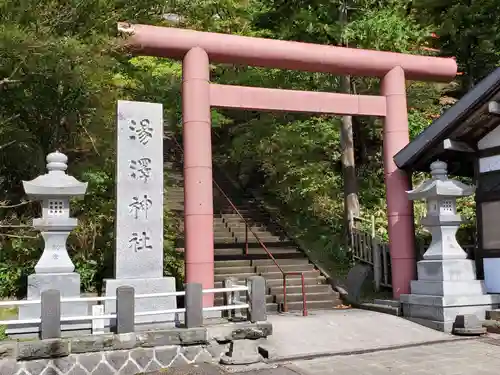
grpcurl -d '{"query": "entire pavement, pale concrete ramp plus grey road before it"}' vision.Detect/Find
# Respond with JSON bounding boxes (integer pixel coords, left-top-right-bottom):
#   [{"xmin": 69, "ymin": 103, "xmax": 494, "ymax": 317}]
[{"xmin": 236, "ymin": 310, "xmax": 500, "ymax": 375}]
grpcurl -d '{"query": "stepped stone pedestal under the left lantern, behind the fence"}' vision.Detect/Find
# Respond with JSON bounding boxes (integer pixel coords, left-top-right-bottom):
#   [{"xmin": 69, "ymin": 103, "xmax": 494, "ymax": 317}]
[{"xmin": 7, "ymin": 272, "xmax": 88, "ymax": 336}]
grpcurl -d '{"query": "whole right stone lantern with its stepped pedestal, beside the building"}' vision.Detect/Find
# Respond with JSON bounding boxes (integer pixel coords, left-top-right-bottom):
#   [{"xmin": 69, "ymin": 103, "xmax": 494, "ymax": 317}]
[{"xmin": 400, "ymin": 161, "xmax": 500, "ymax": 332}]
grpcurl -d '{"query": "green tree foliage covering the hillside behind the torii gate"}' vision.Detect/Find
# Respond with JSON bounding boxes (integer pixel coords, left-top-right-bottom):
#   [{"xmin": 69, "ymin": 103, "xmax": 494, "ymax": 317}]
[{"xmin": 0, "ymin": 0, "xmax": 490, "ymax": 297}]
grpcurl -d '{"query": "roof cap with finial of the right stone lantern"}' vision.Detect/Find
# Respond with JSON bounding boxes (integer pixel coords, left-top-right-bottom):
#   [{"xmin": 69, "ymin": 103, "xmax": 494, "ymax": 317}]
[{"xmin": 407, "ymin": 160, "xmax": 475, "ymax": 200}]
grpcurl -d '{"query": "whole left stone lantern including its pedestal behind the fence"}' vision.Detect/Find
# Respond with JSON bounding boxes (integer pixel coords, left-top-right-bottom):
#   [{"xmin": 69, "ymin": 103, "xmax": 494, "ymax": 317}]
[{"xmin": 19, "ymin": 151, "xmax": 88, "ymax": 319}]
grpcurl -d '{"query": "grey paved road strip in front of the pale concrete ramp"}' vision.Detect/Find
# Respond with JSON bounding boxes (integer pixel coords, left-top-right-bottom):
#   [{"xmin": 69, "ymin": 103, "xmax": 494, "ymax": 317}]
[{"xmin": 294, "ymin": 339, "xmax": 500, "ymax": 375}]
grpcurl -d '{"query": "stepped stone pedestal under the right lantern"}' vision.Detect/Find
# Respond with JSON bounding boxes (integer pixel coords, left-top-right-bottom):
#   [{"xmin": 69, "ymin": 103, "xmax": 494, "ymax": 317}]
[{"xmin": 400, "ymin": 259, "xmax": 500, "ymax": 332}]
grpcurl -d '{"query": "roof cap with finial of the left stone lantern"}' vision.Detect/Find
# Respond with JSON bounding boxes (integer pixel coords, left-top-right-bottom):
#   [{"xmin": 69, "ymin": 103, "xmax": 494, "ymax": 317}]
[{"xmin": 23, "ymin": 151, "xmax": 87, "ymax": 199}]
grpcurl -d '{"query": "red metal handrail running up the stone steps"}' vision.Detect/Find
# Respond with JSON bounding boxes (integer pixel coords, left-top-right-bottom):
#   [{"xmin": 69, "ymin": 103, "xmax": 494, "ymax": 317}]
[{"xmin": 172, "ymin": 136, "xmax": 308, "ymax": 316}]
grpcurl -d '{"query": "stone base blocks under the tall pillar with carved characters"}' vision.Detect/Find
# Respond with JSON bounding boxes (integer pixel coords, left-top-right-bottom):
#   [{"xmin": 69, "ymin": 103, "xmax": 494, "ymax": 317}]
[{"xmin": 104, "ymin": 277, "xmax": 177, "ymax": 327}]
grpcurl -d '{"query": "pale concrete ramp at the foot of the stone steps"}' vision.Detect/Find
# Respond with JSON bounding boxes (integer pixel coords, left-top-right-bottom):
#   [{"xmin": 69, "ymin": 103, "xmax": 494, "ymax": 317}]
[{"xmin": 266, "ymin": 309, "xmax": 456, "ymax": 360}]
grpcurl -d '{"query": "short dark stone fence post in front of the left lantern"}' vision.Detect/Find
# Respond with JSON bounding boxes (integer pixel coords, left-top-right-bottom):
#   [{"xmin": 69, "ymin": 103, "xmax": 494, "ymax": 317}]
[{"xmin": 40, "ymin": 289, "xmax": 61, "ymax": 340}]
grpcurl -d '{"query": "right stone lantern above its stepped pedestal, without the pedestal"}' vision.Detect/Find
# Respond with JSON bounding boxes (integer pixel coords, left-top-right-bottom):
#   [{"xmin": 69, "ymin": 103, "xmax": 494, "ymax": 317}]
[{"xmin": 408, "ymin": 161, "xmax": 475, "ymax": 260}]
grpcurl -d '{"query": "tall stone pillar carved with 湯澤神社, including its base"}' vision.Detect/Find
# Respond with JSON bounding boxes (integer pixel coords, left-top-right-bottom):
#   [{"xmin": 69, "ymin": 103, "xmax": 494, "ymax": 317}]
[{"xmin": 105, "ymin": 100, "xmax": 177, "ymax": 323}]
